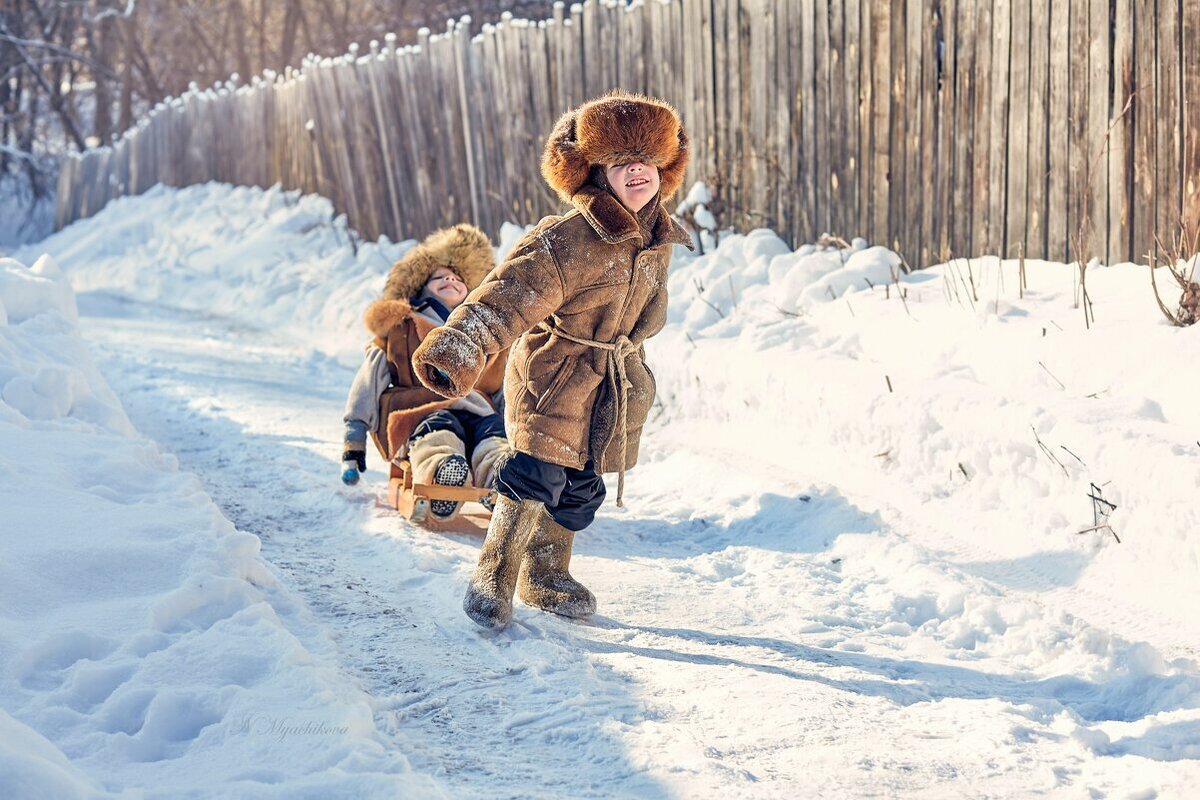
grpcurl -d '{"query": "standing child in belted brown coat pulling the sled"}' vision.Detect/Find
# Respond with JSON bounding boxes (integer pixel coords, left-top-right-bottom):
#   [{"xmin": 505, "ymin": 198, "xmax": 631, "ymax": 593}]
[{"xmin": 413, "ymin": 92, "xmax": 692, "ymax": 628}]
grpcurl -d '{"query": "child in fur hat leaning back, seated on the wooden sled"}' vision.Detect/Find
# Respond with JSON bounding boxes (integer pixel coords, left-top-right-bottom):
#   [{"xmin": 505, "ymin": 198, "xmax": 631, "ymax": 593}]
[{"xmin": 342, "ymin": 224, "xmax": 508, "ymax": 519}]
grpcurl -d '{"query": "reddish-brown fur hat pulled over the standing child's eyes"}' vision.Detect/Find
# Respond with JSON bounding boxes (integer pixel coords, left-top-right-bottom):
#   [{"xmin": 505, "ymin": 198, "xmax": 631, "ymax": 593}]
[{"xmin": 541, "ymin": 90, "xmax": 688, "ymax": 203}]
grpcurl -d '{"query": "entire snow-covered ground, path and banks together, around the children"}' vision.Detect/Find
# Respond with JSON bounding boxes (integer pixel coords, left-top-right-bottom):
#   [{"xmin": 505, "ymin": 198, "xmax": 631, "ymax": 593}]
[{"xmin": 0, "ymin": 185, "xmax": 1200, "ymax": 798}]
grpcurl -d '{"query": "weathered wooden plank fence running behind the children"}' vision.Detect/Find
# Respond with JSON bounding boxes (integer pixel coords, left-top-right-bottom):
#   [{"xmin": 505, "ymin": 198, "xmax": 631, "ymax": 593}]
[{"xmin": 58, "ymin": 0, "xmax": 1200, "ymax": 265}]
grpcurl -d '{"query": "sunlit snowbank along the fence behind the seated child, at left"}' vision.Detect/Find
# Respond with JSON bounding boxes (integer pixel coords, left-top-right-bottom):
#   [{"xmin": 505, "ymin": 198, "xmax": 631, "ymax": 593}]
[{"xmin": 16, "ymin": 184, "xmax": 414, "ymax": 362}]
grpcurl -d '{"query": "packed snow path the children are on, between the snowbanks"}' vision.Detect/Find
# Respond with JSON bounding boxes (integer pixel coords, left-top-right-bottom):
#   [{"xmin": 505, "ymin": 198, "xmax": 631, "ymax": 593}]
[{"xmin": 79, "ymin": 293, "xmax": 1200, "ymax": 798}]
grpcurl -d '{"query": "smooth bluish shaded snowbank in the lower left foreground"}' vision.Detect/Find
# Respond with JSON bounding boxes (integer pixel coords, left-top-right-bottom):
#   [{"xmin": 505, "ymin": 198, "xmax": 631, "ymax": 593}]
[{"xmin": 0, "ymin": 258, "xmax": 439, "ymax": 798}]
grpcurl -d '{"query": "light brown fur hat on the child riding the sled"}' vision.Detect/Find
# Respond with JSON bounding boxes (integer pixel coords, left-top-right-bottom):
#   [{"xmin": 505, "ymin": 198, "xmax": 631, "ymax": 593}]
[{"xmin": 383, "ymin": 223, "xmax": 496, "ymax": 300}]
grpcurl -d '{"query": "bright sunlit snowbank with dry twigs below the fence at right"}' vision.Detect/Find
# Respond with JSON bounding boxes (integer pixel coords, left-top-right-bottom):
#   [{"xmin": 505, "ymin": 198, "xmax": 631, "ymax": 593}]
[{"xmin": 647, "ymin": 230, "xmax": 1200, "ymax": 655}]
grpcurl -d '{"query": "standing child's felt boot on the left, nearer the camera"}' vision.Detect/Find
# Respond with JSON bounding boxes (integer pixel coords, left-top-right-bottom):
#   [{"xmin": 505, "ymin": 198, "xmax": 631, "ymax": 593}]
[{"xmin": 462, "ymin": 494, "xmax": 545, "ymax": 628}]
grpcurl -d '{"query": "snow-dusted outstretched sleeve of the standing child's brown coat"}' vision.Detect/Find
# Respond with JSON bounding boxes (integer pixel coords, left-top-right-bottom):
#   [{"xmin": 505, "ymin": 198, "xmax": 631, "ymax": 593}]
[{"xmin": 413, "ymin": 231, "xmax": 565, "ymax": 397}]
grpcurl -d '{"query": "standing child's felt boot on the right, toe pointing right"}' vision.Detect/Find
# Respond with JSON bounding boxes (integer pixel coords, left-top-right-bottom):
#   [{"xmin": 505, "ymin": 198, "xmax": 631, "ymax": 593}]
[{"xmin": 517, "ymin": 511, "xmax": 596, "ymax": 616}]
